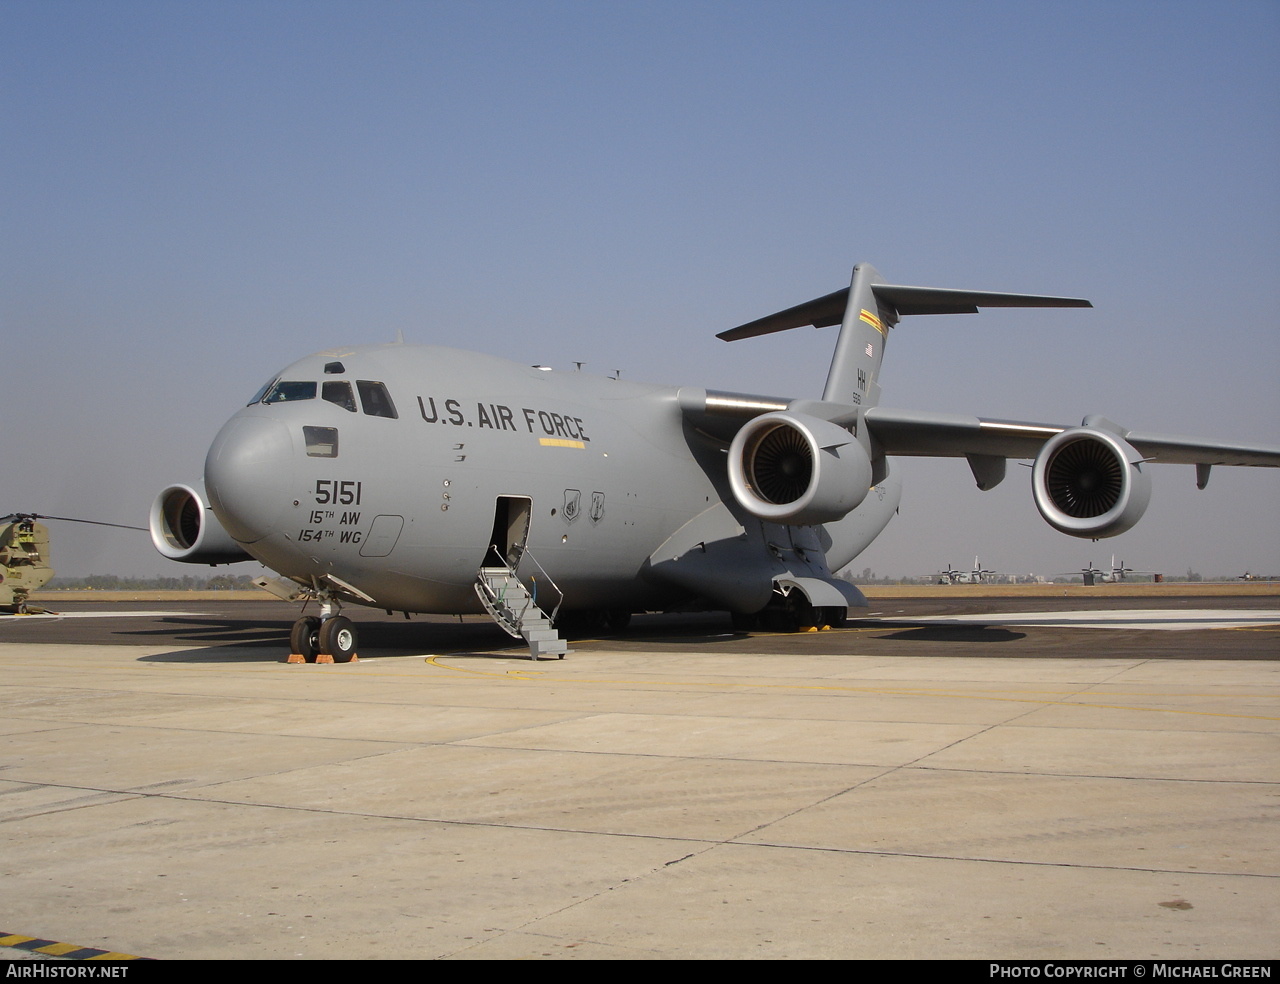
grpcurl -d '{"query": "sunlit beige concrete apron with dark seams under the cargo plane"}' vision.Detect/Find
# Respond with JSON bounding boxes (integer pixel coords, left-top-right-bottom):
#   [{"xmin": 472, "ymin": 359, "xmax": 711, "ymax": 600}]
[{"xmin": 0, "ymin": 598, "xmax": 1280, "ymax": 960}]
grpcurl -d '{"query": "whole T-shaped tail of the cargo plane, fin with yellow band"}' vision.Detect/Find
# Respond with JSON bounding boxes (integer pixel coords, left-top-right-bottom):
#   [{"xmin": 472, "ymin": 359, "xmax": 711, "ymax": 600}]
[{"xmin": 717, "ymin": 264, "xmax": 1093, "ymax": 407}]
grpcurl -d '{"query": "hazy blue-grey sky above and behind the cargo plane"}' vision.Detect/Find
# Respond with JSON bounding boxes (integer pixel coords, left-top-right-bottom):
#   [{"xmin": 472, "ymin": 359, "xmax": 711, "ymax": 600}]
[{"xmin": 0, "ymin": 0, "xmax": 1280, "ymax": 575}]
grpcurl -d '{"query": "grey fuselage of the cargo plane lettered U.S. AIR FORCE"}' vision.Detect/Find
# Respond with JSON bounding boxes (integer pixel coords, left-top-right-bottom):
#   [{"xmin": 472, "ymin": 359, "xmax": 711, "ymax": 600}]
[{"xmin": 205, "ymin": 344, "xmax": 899, "ymax": 613}]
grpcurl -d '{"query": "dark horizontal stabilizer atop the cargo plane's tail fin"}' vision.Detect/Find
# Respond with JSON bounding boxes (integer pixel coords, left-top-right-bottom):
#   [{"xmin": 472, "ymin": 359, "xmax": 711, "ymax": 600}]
[{"xmin": 716, "ymin": 284, "xmax": 1093, "ymax": 342}]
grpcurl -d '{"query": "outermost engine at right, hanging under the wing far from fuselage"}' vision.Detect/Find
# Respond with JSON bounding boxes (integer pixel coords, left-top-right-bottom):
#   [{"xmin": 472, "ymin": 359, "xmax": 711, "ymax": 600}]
[{"xmin": 1032, "ymin": 427, "xmax": 1151, "ymax": 540}]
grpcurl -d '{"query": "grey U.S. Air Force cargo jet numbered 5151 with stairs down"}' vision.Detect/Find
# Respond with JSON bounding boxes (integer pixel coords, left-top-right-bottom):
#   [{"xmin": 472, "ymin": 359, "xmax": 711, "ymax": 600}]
[{"xmin": 150, "ymin": 264, "xmax": 1280, "ymax": 662}]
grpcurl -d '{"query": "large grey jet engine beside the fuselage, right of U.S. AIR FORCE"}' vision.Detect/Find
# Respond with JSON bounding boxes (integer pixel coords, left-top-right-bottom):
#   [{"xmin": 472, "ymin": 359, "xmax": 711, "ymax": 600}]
[{"xmin": 728, "ymin": 411, "xmax": 872, "ymax": 526}]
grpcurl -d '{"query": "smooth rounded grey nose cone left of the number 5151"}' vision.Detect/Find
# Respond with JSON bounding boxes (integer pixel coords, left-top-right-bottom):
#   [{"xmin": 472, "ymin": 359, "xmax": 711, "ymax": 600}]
[{"xmin": 205, "ymin": 415, "xmax": 296, "ymax": 544}]
